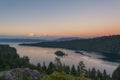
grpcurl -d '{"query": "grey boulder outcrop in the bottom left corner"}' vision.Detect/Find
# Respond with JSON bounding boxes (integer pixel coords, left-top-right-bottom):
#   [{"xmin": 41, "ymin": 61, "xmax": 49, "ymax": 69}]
[{"xmin": 0, "ymin": 68, "xmax": 42, "ymax": 80}]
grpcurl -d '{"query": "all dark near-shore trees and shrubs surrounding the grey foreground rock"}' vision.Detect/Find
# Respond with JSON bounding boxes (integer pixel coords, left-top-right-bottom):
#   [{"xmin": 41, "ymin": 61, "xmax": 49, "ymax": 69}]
[{"xmin": 0, "ymin": 45, "xmax": 120, "ymax": 80}]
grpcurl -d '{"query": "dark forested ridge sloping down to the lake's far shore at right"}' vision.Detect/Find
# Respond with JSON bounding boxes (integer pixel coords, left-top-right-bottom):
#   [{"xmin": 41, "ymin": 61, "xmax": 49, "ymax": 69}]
[{"xmin": 21, "ymin": 35, "xmax": 120, "ymax": 62}]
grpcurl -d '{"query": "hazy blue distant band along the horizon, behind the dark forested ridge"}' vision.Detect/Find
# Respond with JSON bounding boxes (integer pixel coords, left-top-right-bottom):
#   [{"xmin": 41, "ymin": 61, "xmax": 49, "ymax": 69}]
[{"xmin": 0, "ymin": 36, "xmax": 79, "ymax": 42}]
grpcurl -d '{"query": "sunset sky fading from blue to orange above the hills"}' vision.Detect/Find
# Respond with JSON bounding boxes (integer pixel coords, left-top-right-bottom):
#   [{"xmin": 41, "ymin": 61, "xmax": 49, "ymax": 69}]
[{"xmin": 0, "ymin": 0, "xmax": 120, "ymax": 37}]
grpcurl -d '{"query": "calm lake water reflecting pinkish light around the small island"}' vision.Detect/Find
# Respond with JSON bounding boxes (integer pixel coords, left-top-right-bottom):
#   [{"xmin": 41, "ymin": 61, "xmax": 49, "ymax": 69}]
[{"xmin": 0, "ymin": 43, "xmax": 119, "ymax": 74}]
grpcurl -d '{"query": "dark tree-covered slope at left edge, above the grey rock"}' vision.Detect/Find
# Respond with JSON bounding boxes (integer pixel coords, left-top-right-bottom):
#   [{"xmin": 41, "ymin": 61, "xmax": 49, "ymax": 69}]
[{"xmin": 0, "ymin": 45, "xmax": 31, "ymax": 71}]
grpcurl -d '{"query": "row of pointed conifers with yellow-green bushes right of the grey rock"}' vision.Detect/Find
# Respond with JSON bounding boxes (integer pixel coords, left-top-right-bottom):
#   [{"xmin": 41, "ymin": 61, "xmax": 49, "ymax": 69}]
[{"xmin": 38, "ymin": 58, "xmax": 111, "ymax": 80}]
